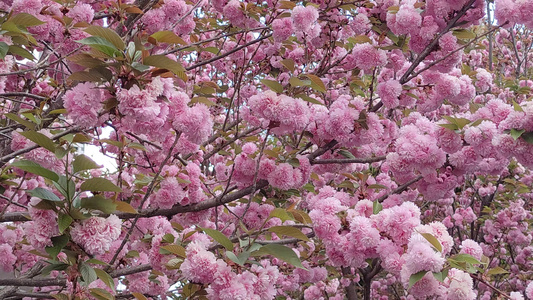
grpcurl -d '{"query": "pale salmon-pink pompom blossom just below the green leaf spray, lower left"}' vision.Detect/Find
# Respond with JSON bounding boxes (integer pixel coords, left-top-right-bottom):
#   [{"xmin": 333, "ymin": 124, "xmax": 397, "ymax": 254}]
[{"xmin": 70, "ymin": 215, "xmax": 122, "ymax": 255}]
